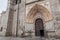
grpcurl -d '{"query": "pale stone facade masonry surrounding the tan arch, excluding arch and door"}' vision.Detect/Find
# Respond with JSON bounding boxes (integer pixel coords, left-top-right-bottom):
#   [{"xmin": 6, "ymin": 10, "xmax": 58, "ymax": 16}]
[{"xmin": 1, "ymin": 0, "xmax": 60, "ymax": 36}]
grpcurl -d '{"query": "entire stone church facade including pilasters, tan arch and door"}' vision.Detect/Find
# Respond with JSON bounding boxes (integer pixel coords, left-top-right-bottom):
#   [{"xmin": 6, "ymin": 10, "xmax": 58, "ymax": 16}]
[{"xmin": 0, "ymin": 0, "xmax": 60, "ymax": 37}]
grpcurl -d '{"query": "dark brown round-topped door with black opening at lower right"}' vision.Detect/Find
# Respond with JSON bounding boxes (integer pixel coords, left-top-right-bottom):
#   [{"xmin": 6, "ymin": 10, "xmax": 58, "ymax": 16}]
[{"xmin": 35, "ymin": 18, "xmax": 44, "ymax": 37}]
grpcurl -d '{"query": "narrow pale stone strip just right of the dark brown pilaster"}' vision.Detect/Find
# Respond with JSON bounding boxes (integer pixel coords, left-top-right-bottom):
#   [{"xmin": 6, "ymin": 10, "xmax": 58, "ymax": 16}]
[{"xmin": 12, "ymin": 5, "xmax": 17, "ymax": 36}]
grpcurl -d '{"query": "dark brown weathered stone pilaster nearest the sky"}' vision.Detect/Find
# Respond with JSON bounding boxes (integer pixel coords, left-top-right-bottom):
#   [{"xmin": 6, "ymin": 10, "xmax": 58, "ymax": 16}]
[{"xmin": 6, "ymin": 0, "xmax": 14, "ymax": 36}]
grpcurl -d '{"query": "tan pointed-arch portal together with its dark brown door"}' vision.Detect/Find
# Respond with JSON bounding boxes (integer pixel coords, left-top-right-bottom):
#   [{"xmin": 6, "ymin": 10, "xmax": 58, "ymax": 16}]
[{"xmin": 26, "ymin": 4, "xmax": 53, "ymax": 37}]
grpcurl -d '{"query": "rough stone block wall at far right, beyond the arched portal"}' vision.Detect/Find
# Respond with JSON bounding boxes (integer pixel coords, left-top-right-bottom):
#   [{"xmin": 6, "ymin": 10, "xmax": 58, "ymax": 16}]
[{"xmin": 49, "ymin": 0, "xmax": 60, "ymax": 36}]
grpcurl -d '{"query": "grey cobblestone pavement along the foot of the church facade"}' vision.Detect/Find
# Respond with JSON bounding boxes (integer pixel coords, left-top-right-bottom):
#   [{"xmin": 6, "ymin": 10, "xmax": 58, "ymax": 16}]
[{"xmin": 0, "ymin": 37, "xmax": 60, "ymax": 40}]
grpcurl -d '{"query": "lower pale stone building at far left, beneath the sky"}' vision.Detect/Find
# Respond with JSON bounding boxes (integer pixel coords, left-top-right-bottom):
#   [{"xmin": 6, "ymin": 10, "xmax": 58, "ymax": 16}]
[{"xmin": 0, "ymin": 11, "xmax": 8, "ymax": 36}]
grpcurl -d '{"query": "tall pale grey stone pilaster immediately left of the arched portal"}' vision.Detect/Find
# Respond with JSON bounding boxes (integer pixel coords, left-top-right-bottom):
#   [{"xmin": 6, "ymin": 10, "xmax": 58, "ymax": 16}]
[{"xmin": 18, "ymin": 0, "xmax": 26, "ymax": 36}]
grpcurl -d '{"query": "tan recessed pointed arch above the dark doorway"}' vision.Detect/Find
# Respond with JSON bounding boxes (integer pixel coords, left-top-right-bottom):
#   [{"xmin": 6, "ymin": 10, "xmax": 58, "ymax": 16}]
[{"xmin": 27, "ymin": 4, "xmax": 53, "ymax": 23}]
